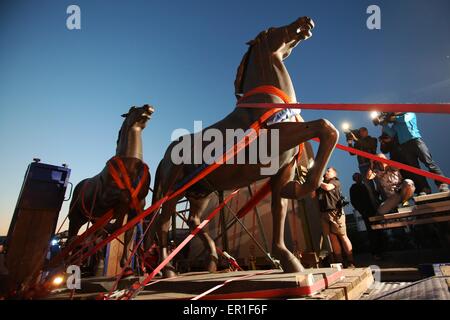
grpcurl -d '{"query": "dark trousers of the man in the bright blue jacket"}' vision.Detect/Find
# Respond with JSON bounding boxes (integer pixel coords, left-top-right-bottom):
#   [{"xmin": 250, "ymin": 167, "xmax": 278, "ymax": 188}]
[{"xmin": 401, "ymin": 138, "xmax": 444, "ymax": 192}]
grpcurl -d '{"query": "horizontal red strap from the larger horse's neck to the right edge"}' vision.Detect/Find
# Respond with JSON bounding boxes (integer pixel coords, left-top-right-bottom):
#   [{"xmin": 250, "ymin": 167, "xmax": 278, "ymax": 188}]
[{"xmin": 237, "ymin": 103, "xmax": 450, "ymax": 114}]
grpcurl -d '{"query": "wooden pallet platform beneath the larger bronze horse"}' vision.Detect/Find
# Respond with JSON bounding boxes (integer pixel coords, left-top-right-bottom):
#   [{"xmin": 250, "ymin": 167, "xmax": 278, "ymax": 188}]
[{"xmin": 49, "ymin": 268, "xmax": 373, "ymax": 300}]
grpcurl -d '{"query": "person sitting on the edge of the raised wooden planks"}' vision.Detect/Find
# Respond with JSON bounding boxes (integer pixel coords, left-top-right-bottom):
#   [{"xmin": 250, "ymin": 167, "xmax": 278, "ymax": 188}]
[{"xmin": 366, "ymin": 153, "xmax": 415, "ymax": 214}]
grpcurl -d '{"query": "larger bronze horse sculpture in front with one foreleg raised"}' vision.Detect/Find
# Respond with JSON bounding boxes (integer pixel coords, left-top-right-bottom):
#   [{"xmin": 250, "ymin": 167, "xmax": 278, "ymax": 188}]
[{"xmin": 146, "ymin": 17, "xmax": 339, "ymax": 277}]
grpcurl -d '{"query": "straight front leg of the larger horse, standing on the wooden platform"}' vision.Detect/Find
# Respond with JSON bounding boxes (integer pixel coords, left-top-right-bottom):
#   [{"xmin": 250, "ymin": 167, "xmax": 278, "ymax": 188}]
[{"xmin": 270, "ymin": 160, "xmax": 304, "ymax": 272}]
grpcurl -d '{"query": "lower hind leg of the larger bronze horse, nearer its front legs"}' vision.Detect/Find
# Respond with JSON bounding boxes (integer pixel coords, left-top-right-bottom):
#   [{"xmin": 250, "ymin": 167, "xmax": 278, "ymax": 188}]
[{"xmin": 189, "ymin": 198, "xmax": 219, "ymax": 273}]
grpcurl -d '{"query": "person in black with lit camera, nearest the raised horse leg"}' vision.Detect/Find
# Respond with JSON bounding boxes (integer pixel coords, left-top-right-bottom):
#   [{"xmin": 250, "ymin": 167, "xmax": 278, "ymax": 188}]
[{"xmin": 346, "ymin": 127, "xmax": 378, "ymax": 177}]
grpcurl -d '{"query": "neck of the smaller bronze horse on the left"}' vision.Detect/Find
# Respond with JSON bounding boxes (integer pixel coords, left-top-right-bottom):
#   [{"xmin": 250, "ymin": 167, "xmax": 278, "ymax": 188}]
[{"xmin": 116, "ymin": 126, "xmax": 144, "ymax": 160}]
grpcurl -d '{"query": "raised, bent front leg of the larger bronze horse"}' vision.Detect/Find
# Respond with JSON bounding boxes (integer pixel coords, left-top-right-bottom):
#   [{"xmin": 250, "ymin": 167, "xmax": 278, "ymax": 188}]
[{"xmin": 269, "ymin": 119, "xmax": 339, "ymax": 199}]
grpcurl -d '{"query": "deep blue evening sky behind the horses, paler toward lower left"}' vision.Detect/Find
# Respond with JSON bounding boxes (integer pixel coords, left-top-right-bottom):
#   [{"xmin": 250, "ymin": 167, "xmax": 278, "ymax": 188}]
[{"xmin": 0, "ymin": 0, "xmax": 450, "ymax": 234}]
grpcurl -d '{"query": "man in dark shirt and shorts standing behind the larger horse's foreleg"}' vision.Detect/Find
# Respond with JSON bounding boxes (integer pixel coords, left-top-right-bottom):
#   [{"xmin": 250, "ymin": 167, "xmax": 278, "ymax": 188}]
[{"xmin": 316, "ymin": 167, "xmax": 355, "ymax": 268}]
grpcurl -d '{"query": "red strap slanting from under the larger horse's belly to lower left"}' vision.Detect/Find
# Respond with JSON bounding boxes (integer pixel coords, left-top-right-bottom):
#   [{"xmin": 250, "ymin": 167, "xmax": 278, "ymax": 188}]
[{"xmin": 124, "ymin": 189, "xmax": 239, "ymax": 300}]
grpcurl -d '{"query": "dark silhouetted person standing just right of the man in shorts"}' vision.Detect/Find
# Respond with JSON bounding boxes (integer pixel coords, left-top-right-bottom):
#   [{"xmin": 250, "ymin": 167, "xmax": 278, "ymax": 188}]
[{"xmin": 350, "ymin": 172, "xmax": 383, "ymax": 260}]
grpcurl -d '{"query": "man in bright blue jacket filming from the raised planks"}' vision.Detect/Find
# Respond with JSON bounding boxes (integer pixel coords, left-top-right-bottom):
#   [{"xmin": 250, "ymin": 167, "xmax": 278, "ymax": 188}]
[{"xmin": 383, "ymin": 112, "xmax": 449, "ymax": 194}]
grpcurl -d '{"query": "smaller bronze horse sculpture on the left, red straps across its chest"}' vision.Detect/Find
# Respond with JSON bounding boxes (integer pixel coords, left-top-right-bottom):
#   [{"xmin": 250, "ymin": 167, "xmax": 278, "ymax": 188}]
[{"xmin": 68, "ymin": 105, "xmax": 154, "ymax": 267}]
